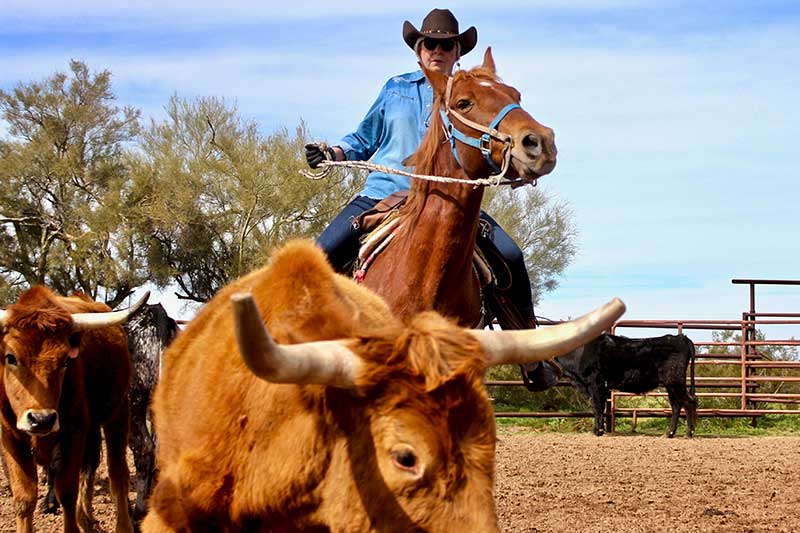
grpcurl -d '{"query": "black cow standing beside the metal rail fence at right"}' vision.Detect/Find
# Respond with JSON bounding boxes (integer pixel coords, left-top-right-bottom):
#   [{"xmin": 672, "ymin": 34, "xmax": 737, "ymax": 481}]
[{"xmin": 558, "ymin": 334, "xmax": 697, "ymax": 437}]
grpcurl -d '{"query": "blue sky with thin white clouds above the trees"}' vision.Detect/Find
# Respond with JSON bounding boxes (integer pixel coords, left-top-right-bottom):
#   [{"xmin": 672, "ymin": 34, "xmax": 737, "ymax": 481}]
[{"xmin": 0, "ymin": 0, "xmax": 800, "ymax": 336}]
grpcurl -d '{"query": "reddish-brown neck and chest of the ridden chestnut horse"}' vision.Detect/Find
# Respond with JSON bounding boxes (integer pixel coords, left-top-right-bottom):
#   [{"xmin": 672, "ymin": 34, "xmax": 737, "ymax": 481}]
[{"xmin": 367, "ymin": 100, "xmax": 483, "ymax": 326}]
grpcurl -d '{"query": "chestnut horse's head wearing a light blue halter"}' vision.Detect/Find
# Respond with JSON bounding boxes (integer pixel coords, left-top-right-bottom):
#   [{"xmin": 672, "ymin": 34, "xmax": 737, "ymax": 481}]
[{"xmin": 412, "ymin": 48, "xmax": 557, "ymax": 180}]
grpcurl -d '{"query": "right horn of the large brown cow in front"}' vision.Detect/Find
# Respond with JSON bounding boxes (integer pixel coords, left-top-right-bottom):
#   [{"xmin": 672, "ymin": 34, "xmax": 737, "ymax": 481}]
[{"xmin": 470, "ymin": 298, "xmax": 625, "ymax": 366}]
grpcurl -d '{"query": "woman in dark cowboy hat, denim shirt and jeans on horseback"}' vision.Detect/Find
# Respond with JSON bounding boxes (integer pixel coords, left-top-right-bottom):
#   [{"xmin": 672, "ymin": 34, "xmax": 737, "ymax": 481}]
[{"xmin": 306, "ymin": 9, "xmax": 535, "ymax": 320}]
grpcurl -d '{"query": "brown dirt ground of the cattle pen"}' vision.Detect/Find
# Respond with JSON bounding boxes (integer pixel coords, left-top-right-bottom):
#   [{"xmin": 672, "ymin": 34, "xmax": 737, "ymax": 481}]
[{"xmin": 0, "ymin": 428, "xmax": 800, "ymax": 533}]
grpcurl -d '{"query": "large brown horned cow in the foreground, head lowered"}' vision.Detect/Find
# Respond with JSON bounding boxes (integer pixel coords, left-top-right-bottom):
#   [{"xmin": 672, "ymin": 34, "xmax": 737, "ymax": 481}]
[{"xmin": 142, "ymin": 242, "xmax": 624, "ymax": 532}]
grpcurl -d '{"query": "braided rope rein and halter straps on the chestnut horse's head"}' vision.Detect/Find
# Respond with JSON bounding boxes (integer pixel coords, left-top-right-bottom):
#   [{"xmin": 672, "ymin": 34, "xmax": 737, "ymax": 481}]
[{"xmin": 300, "ymin": 76, "xmax": 538, "ymax": 188}]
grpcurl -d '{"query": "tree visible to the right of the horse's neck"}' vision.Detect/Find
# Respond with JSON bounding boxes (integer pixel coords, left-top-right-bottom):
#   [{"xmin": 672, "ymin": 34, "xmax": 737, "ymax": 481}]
[{"xmin": 484, "ymin": 187, "xmax": 578, "ymax": 304}]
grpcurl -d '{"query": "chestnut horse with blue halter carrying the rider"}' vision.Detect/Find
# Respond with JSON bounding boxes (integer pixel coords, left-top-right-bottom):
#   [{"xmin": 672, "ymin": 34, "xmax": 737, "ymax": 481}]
[{"xmin": 364, "ymin": 48, "xmax": 556, "ymax": 327}]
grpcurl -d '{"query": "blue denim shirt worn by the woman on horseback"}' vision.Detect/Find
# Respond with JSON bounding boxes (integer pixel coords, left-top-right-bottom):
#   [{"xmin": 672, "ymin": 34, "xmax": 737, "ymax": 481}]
[{"xmin": 339, "ymin": 70, "xmax": 433, "ymax": 200}]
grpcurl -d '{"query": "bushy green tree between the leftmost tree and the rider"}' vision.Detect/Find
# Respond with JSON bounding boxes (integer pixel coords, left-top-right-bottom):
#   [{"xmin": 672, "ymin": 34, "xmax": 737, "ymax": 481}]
[{"xmin": 134, "ymin": 96, "xmax": 363, "ymax": 302}]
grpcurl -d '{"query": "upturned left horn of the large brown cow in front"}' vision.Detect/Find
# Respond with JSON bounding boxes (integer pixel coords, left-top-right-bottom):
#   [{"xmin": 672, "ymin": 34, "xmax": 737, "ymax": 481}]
[{"xmin": 231, "ymin": 293, "xmax": 362, "ymax": 389}]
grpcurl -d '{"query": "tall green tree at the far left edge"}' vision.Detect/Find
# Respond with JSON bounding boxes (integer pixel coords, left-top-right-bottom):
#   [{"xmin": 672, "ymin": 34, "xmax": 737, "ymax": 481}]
[{"xmin": 0, "ymin": 61, "xmax": 146, "ymax": 306}]
